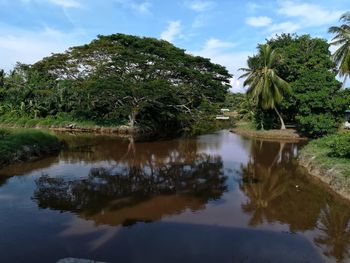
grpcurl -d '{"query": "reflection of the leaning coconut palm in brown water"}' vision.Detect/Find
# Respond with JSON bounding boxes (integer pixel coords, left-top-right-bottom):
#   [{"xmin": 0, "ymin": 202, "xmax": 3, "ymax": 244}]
[{"xmin": 240, "ymin": 141, "xmax": 294, "ymax": 225}]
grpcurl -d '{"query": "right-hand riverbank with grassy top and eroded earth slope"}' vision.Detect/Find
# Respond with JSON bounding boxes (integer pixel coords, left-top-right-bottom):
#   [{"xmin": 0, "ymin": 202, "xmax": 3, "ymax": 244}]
[{"xmin": 298, "ymin": 136, "xmax": 350, "ymax": 200}]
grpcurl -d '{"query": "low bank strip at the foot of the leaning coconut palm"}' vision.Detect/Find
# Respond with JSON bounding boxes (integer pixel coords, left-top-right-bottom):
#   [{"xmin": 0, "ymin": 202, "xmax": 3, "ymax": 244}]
[{"xmin": 230, "ymin": 122, "xmax": 307, "ymax": 141}]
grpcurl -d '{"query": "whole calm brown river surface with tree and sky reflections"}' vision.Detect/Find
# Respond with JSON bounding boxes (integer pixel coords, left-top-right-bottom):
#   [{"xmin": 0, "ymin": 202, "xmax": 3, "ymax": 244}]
[{"xmin": 0, "ymin": 131, "xmax": 350, "ymax": 263}]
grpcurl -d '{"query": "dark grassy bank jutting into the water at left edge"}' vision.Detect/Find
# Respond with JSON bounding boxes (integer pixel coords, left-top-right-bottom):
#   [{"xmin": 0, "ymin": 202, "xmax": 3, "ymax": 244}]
[{"xmin": 0, "ymin": 129, "xmax": 62, "ymax": 168}]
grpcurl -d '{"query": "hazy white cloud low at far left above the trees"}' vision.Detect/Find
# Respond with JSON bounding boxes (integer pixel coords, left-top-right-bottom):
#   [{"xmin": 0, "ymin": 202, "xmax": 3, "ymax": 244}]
[{"xmin": 0, "ymin": 28, "xmax": 79, "ymax": 71}]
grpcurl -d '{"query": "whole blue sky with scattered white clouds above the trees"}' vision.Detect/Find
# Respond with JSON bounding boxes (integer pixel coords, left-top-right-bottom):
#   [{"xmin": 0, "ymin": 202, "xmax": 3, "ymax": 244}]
[{"xmin": 0, "ymin": 0, "xmax": 350, "ymax": 92}]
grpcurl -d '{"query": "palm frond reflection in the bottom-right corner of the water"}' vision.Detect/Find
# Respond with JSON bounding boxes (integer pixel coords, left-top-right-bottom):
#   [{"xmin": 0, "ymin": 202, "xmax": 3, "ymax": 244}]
[{"xmin": 315, "ymin": 204, "xmax": 350, "ymax": 262}]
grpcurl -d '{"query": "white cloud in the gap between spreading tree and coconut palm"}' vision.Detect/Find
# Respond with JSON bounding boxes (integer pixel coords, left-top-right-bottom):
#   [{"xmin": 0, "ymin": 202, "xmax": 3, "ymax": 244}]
[{"xmin": 191, "ymin": 38, "xmax": 251, "ymax": 92}]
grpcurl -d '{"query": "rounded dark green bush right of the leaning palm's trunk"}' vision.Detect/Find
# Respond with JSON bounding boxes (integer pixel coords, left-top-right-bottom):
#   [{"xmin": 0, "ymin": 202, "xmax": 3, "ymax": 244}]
[{"xmin": 296, "ymin": 114, "xmax": 338, "ymax": 138}]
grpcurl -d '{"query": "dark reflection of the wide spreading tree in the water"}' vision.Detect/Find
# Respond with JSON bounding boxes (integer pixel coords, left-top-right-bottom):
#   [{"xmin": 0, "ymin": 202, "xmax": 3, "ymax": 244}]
[{"xmin": 33, "ymin": 141, "xmax": 227, "ymax": 225}]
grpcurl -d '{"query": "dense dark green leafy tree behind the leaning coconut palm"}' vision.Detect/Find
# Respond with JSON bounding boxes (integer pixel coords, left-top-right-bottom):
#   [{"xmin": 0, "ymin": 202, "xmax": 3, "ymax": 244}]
[{"xmin": 234, "ymin": 34, "xmax": 350, "ymax": 137}]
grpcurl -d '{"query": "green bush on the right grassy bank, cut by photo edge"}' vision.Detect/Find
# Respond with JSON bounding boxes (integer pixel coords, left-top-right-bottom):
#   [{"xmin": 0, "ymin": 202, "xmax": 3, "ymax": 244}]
[{"xmin": 327, "ymin": 133, "xmax": 350, "ymax": 158}]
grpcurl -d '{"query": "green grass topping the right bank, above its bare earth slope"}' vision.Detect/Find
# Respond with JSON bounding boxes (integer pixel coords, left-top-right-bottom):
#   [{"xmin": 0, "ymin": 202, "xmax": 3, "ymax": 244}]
[{"xmin": 300, "ymin": 134, "xmax": 350, "ymax": 177}]
